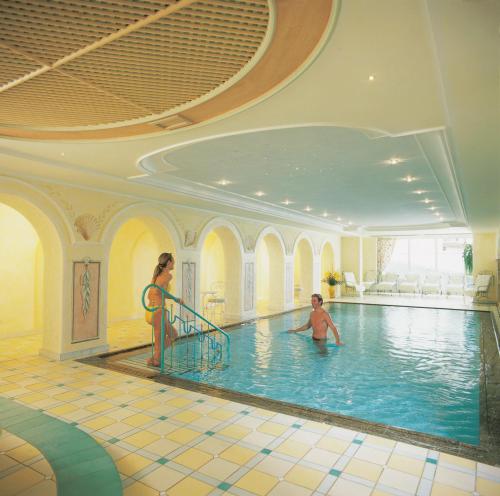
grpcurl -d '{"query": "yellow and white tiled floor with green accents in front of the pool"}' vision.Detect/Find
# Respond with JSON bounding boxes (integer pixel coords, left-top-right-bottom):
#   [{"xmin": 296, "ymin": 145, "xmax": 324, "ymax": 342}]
[{"xmin": 0, "ymin": 300, "xmax": 500, "ymax": 496}]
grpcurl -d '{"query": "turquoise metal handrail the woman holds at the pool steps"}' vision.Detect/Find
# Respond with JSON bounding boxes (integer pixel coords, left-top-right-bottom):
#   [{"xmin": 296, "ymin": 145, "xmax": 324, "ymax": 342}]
[{"xmin": 141, "ymin": 284, "xmax": 231, "ymax": 373}]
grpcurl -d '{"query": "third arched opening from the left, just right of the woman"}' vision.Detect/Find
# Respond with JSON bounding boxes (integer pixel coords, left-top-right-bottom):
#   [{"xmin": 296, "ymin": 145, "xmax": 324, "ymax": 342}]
[{"xmin": 200, "ymin": 226, "xmax": 243, "ymax": 325}]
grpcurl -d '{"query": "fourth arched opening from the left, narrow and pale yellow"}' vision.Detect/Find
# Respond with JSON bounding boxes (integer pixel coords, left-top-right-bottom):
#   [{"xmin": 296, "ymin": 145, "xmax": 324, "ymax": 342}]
[{"xmin": 255, "ymin": 234, "xmax": 285, "ymax": 315}]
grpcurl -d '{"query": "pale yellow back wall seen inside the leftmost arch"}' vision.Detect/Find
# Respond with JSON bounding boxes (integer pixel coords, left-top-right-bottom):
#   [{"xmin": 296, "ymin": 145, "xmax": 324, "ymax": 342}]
[{"xmin": 0, "ymin": 204, "xmax": 43, "ymax": 338}]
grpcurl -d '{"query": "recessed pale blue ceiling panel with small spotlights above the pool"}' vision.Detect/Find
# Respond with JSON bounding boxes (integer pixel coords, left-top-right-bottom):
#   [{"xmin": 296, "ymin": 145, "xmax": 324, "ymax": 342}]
[{"xmin": 141, "ymin": 126, "xmax": 464, "ymax": 228}]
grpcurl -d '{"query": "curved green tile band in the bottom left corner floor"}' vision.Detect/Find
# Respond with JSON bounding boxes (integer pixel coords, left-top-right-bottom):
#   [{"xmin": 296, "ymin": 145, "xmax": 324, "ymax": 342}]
[{"xmin": 0, "ymin": 398, "xmax": 122, "ymax": 496}]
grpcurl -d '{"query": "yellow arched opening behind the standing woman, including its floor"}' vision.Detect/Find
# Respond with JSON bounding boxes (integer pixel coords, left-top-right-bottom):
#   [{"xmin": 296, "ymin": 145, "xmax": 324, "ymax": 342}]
[{"xmin": 108, "ymin": 216, "xmax": 177, "ymax": 350}]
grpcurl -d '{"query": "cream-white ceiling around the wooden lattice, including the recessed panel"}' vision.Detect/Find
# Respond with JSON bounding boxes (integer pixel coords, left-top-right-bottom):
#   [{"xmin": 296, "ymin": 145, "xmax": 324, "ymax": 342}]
[{"xmin": 0, "ymin": 0, "xmax": 500, "ymax": 230}]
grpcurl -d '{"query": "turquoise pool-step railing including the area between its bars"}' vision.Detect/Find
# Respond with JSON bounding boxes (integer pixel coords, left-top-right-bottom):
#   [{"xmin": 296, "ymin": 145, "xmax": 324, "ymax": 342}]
[{"xmin": 142, "ymin": 284, "xmax": 230, "ymax": 374}]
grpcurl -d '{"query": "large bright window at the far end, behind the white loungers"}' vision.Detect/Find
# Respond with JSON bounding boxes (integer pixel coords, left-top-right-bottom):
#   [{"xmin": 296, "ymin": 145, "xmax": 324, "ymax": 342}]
[{"xmin": 385, "ymin": 236, "xmax": 472, "ymax": 274}]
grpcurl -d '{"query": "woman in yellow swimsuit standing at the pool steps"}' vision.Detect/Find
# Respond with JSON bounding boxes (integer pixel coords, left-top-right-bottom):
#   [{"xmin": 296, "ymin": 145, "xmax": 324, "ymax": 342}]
[{"xmin": 146, "ymin": 253, "xmax": 184, "ymax": 367}]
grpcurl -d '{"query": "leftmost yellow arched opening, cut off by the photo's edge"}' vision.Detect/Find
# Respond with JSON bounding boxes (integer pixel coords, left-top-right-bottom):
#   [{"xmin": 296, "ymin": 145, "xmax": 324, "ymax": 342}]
[{"xmin": 0, "ymin": 200, "xmax": 63, "ymax": 359}]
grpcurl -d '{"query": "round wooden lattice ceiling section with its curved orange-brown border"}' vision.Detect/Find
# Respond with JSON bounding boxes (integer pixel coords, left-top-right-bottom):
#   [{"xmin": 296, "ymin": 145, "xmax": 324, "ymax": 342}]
[{"xmin": 0, "ymin": 0, "xmax": 338, "ymax": 140}]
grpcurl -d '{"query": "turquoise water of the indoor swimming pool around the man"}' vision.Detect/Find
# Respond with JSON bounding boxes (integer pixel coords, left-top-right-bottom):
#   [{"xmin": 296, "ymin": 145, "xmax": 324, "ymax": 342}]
[{"xmin": 176, "ymin": 304, "xmax": 480, "ymax": 444}]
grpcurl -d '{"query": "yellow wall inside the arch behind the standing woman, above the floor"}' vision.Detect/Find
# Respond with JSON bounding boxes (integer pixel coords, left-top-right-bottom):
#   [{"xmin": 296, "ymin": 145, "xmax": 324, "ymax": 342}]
[{"xmin": 108, "ymin": 218, "xmax": 175, "ymax": 322}]
